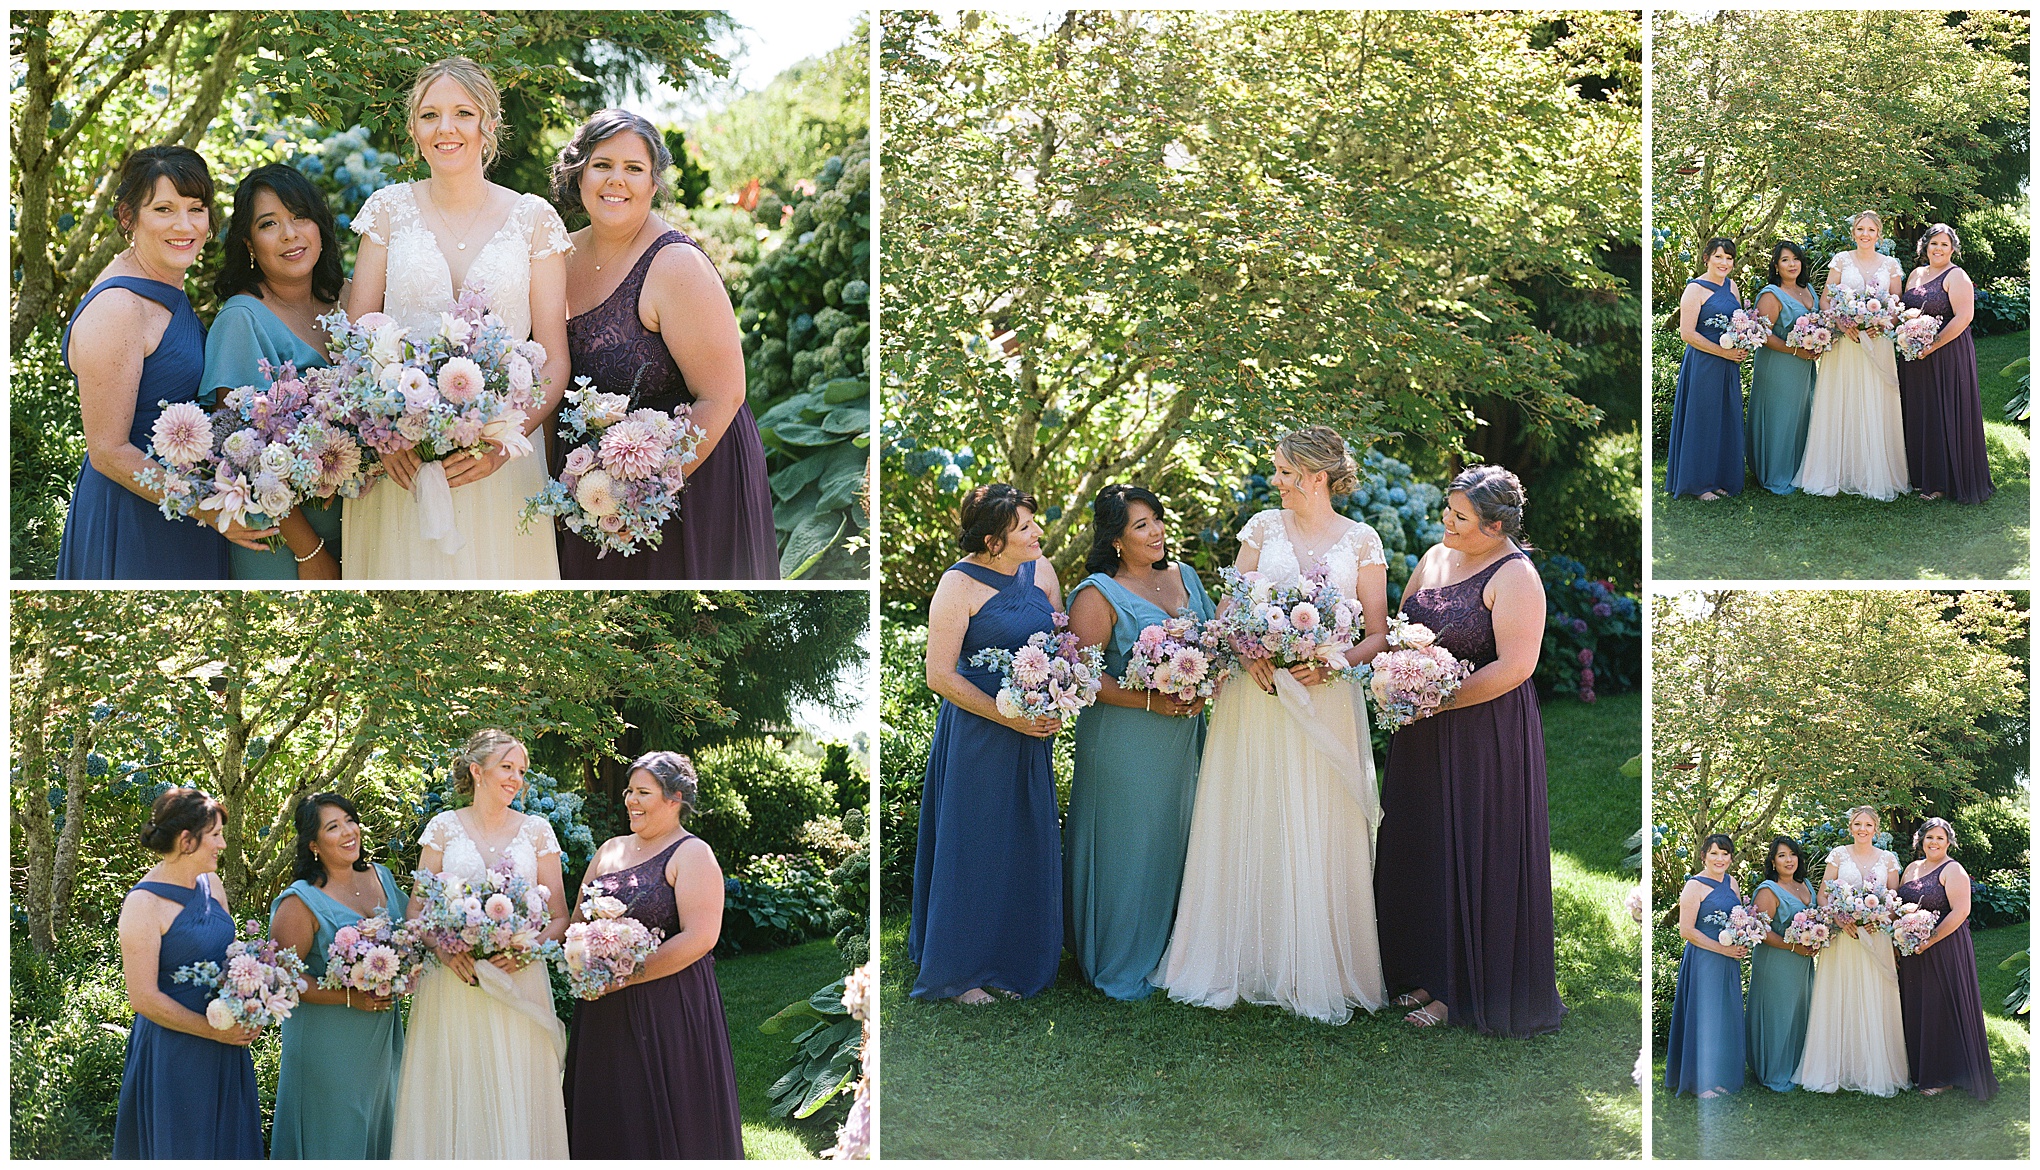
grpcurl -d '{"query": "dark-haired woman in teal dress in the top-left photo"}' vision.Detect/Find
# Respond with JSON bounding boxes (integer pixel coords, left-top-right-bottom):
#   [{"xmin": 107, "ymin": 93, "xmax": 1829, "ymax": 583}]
[{"xmin": 200, "ymin": 163, "xmax": 347, "ymax": 581}]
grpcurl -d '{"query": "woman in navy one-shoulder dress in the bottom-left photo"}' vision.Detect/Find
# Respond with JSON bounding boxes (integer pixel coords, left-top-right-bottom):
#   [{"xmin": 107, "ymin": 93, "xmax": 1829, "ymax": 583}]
[{"xmin": 114, "ymin": 789, "xmax": 263, "ymax": 1160}]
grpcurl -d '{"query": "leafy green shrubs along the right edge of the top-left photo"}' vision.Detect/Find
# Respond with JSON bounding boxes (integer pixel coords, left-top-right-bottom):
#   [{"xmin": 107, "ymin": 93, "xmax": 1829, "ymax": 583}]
[{"xmin": 736, "ymin": 141, "xmax": 871, "ymax": 579}]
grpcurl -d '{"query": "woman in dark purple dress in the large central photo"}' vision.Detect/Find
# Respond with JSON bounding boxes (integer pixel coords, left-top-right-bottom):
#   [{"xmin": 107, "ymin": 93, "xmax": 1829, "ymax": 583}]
[{"xmin": 1375, "ymin": 467, "xmax": 1565, "ymax": 1035}]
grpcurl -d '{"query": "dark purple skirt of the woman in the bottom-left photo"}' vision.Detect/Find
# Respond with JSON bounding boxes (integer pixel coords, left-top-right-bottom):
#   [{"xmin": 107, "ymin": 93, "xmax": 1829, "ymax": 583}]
[{"xmin": 565, "ymin": 954, "xmax": 745, "ymax": 1158}]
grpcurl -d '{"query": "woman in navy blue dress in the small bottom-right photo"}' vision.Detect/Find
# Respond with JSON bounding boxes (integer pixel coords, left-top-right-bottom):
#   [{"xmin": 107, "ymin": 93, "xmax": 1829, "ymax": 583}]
[{"xmin": 1665, "ymin": 834, "xmax": 1750, "ymax": 1099}]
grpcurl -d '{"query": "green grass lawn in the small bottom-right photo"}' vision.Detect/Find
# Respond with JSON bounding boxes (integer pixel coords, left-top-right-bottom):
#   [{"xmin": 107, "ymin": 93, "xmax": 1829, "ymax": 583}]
[{"xmin": 1650, "ymin": 923, "xmax": 2032, "ymax": 1160}]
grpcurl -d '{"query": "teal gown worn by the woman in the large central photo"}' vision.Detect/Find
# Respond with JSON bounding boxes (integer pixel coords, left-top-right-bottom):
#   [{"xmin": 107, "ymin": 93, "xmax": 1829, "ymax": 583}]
[{"xmin": 1063, "ymin": 563, "xmax": 1216, "ymax": 999}]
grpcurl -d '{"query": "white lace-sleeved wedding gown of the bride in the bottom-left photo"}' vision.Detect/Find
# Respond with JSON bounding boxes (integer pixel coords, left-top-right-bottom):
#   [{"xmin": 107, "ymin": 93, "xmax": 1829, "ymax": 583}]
[{"xmin": 390, "ymin": 811, "xmax": 567, "ymax": 1160}]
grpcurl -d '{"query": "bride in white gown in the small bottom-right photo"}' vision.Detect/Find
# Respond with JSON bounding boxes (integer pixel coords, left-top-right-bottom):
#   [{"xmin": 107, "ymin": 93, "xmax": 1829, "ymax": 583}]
[{"xmin": 1793, "ymin": 805, "xmax": 1911, "ymax": 1097}]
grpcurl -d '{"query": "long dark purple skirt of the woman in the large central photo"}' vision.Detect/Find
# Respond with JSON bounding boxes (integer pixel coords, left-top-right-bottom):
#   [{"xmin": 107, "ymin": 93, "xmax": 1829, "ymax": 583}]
[{"xmin": 1375, "ymin": 683, "xmax": 1565, "ymax": 1035}]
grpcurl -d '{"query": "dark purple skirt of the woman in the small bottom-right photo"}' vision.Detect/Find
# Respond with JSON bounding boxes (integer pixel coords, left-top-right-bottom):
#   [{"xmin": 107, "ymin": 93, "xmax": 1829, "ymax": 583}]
[{"xmin": 1899, "ymin": 925, "xmax": 1997, "ymax": 1101}]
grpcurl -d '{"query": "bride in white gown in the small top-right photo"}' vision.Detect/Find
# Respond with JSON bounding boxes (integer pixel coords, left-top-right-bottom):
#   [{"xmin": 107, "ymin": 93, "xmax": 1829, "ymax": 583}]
[{"xmin": 1793, "ymin": 212, "xmax": 1911, "ymax": 499}]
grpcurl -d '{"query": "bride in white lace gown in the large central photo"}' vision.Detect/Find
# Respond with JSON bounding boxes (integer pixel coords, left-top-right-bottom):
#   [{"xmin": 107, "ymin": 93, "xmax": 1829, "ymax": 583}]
[{"xmin": 1149, "ymin": 426, "xmax": 1387, "ymax": 1023}]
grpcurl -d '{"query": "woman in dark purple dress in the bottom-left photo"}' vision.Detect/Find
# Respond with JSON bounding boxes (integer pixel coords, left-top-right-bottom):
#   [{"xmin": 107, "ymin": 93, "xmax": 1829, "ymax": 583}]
[{"xmin": 565, "ymin": 752, "xmax": 745, "ymax": 1158}]
